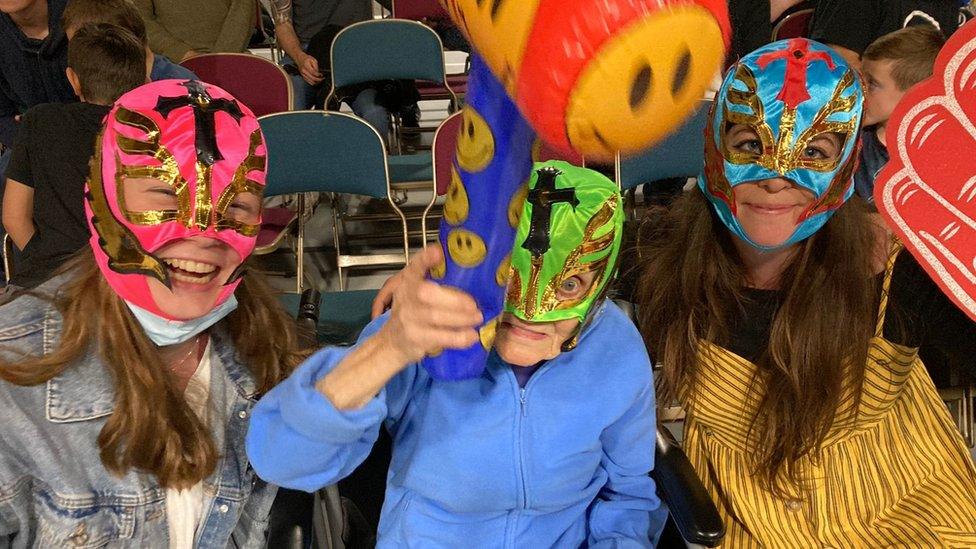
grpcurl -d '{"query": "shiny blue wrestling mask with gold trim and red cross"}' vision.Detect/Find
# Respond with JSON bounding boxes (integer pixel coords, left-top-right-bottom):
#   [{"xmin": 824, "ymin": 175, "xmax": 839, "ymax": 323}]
[{"xmin": 698, "ymin": 38, "xmax": 864, "ymax": 250}]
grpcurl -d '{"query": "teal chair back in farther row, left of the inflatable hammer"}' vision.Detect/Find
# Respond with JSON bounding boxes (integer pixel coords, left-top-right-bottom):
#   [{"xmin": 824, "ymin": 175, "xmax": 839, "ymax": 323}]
[{"xmin": 332, "ymin": 19, "xmax": 447, "ymax": 90}]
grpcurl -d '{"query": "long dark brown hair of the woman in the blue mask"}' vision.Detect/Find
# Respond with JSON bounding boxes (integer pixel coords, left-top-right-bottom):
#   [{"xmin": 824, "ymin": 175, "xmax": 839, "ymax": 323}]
[{"xmin": 637, "ymin": 189, "xmax": 878, "ymax": 495}]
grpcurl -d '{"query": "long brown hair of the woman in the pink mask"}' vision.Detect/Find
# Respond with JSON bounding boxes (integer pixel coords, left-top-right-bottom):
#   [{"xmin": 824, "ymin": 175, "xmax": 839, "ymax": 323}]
[{"xmin": 0, "ymin": 252, "xmax": 307, "ymax": 489}]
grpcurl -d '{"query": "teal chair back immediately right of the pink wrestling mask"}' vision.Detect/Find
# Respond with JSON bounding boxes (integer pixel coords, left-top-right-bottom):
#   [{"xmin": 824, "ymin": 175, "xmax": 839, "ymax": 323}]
[{"xmin": 258, "ymin": 111, "xmax": 390, "ymax": 198}]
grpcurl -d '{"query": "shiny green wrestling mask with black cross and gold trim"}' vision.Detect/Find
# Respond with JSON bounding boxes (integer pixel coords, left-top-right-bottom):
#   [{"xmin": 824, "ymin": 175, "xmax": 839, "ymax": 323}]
[{"xmin": 505, "ymin": 161, "xmax": 624, "ymax": 328}]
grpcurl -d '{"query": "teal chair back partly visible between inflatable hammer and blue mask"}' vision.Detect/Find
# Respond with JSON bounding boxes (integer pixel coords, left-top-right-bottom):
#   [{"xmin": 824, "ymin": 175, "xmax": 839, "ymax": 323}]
[{"xmin": 615, "ymin": 101, "xmax": 708, "ymax": 190}]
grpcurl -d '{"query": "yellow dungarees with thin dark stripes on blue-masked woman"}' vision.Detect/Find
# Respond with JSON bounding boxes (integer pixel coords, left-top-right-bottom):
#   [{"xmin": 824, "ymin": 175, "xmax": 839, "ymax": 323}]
[{"xmin": 682, "ymin": 250, "xmax": 976, "ymax": 549}]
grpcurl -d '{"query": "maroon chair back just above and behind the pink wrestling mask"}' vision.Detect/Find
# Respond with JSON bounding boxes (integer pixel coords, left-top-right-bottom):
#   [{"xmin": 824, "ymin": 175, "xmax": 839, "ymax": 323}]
[{"xmin": 180, "ymin": 53, "xmax": 292, "ymax": 116}]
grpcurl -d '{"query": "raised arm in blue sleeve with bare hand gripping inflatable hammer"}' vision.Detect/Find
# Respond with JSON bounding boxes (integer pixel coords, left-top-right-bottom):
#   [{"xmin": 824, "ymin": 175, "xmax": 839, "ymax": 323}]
[{"xmin": 247, "ymin": 246, "xmax": 481, "ymax": 491}]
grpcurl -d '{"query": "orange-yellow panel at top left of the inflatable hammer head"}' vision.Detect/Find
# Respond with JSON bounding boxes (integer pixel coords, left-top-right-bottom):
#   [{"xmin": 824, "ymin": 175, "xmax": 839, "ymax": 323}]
[{"xmin": 442, "ymin": 0, "xmax": 540, "ymax": 97}]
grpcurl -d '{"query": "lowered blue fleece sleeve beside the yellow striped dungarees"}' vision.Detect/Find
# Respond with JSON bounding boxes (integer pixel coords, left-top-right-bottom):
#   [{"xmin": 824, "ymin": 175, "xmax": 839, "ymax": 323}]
[{"xmin": 588, "ymin": 370, "xmax": 667, "ymax": 548}]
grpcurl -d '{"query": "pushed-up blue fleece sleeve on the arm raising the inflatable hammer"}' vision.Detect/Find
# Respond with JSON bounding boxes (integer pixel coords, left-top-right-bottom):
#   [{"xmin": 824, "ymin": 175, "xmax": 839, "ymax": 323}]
[{"xmin": 247, "ymin": 317, "xmax": 418, "ymax": 492}]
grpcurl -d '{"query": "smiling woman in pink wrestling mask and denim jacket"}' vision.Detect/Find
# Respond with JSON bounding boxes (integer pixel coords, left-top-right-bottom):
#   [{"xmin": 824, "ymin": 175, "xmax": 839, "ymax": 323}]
[{"xmin": 0, "ymin": 80, "xmax": 302, "ymax": 548}]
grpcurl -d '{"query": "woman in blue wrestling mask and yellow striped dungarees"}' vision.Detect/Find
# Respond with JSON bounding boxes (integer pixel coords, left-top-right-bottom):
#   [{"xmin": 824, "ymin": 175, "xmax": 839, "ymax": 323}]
[{"xmin": 637, "ymin": 39, "xmax": 976, "ymax": 547}]
